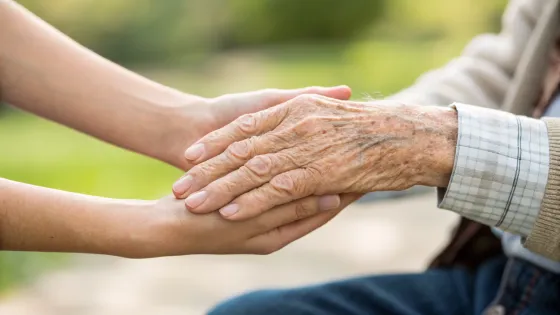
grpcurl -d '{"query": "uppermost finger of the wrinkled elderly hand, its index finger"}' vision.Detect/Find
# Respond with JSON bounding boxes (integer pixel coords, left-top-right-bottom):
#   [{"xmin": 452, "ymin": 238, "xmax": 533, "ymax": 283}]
[{"xmin": 185, "ymin": 104, "xmax": 288, "ymax": 164}]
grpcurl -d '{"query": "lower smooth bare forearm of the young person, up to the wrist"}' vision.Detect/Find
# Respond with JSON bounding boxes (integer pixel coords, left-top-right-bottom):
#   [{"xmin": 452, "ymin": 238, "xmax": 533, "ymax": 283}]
[{"xmin": 0, "ymin": 179, "xmax": 158, "ymax": 256}]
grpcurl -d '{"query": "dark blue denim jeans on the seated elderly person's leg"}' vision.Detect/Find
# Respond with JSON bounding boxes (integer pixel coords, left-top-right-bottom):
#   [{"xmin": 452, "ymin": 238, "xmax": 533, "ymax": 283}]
[{"xmin": 209, "ymin": 257, "xmax": 560, "ymax": 315}]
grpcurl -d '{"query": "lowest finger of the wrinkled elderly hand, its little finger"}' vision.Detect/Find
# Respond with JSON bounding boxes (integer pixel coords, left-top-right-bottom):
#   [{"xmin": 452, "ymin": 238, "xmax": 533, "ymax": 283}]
[{"xmin": 220, "ymin": 169, "xmax": 318, "ymax": 220}]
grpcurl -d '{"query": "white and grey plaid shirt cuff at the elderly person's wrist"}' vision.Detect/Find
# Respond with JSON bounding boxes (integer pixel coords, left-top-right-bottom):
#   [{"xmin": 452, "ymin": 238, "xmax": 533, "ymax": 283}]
[{"xmin": 438, "ymin": 103, "xmax": 549, "ymax": 236}]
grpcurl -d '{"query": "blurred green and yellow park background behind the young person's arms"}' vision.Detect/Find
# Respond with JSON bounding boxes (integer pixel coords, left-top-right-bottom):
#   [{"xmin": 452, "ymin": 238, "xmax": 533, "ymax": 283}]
[{"xmin": 0, "ymin": 0, "xmax": 507, "ymax": 290}]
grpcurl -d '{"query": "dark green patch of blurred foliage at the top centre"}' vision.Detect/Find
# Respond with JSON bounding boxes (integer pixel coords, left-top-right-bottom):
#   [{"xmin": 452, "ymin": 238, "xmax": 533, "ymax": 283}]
[{"xmin": 224, "ymin": 0, "xmax": 387, "ymax": 46}]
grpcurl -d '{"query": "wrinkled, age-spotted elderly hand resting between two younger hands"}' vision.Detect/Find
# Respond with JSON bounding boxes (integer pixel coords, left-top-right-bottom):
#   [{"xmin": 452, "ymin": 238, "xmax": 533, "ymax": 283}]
[{"xmin": 174, "ymin": 95, "xmax": 457, "ymax": 220}]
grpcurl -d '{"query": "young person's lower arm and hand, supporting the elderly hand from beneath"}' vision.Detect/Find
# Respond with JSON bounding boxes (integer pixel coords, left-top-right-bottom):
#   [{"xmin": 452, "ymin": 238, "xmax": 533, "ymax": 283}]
[{"xmin": 0, "ymin": 179, "xmax": 350, "ymax": 258}]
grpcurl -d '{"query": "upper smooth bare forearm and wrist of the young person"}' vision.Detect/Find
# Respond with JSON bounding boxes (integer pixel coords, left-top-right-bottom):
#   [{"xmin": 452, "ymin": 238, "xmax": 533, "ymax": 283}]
[{"xmin": 0, "ymin": 1, "xmax": 201, "ymax": 169}]
